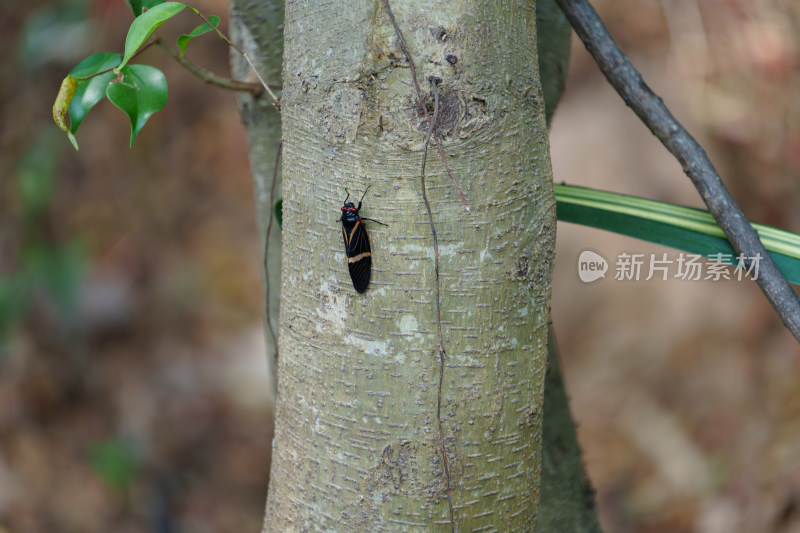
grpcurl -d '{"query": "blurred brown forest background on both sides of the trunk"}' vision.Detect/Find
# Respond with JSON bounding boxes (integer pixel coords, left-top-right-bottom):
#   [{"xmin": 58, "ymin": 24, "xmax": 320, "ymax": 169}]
[{"xmin": 0, "ymin": 0, "xmax": 800, "ymax": 533}]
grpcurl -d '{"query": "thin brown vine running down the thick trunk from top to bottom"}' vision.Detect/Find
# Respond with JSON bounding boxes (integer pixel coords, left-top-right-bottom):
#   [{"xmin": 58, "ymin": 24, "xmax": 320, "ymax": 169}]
[{"xmin": 383, "ymin": 0, "xmax": 460, "ymax": 533}]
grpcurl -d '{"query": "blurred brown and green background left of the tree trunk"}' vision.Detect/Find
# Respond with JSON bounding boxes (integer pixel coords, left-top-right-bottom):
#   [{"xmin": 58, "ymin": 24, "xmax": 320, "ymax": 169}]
[{"xmin": 0, "ymin": 0, "xmax": 272, "ymax": 532}]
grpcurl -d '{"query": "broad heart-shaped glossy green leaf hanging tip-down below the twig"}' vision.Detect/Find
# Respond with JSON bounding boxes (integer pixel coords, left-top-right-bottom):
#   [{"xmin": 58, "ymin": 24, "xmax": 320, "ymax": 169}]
[{"xmin": 106, "ymin": 65, "xmax": 167, "ymax": 146}]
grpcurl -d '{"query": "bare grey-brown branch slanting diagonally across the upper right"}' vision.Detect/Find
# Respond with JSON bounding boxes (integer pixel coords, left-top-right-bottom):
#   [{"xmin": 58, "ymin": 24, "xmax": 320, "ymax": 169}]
[{"xmin": 556, "ymin": 0, "xmax": 800, "ymax": 341}]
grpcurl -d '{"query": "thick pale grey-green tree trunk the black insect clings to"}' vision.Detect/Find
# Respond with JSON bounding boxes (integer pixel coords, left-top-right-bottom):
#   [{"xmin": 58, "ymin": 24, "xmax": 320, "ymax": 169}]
[{"xmin": 233, "ymin": 0, "xmax": 580, "ymax": 531}]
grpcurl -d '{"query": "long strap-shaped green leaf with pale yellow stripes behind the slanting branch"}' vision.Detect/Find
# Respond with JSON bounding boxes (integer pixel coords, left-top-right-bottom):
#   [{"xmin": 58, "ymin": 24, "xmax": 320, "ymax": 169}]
[{"xmin": 554, "ymin": 185, "xmax": 800, "ymax": 285}]
